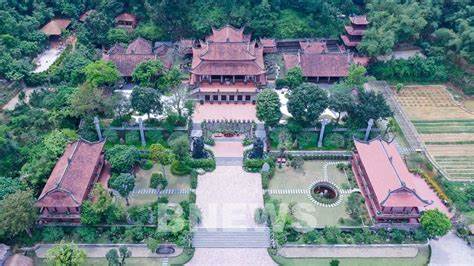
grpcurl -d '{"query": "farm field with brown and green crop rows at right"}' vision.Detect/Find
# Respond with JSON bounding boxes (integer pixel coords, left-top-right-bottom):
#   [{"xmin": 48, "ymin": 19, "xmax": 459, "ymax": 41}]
[{"xmin": 395, "ymin": 85, "xmax": 474, "ymax": 179}]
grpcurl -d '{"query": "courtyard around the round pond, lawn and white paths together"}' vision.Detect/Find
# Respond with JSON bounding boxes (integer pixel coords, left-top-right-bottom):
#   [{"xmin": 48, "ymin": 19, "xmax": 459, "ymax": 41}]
[{"xmin": 268, "ymin": 160, "xmax": 361, "ymax": 228}]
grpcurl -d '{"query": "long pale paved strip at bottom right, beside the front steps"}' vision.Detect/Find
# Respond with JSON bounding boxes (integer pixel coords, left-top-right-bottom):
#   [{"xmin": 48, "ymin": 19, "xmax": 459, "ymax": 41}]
[{"xmin": 278, "ymin": 243, "xmax": 428, "ymax": 258}]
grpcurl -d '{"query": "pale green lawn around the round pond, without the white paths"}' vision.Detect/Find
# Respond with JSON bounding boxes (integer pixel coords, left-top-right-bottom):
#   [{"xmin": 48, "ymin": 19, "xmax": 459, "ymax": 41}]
[{"xmin": 268, "ymin": 160, "xmax": 362, "ymax": 227}]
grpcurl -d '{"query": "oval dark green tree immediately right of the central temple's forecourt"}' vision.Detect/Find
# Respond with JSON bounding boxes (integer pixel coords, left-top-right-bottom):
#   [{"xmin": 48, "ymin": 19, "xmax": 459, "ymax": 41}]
[{"xmin": 257, "ymin": 89, "xmax": 281, "ymax": 126}]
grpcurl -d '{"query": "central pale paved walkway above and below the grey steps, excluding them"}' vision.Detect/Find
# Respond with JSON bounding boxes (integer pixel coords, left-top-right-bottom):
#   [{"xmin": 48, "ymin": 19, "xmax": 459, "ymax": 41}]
[{"xmin": 187, "ymin": 140, "xmax": 276, "ymax": 266}]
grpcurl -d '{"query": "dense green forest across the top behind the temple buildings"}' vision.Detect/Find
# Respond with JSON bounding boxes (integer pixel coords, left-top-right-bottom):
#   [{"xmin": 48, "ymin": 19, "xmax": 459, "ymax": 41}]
[{"xmin": 0, "ymin": 0, "xmax": 474, "ymax": 84}]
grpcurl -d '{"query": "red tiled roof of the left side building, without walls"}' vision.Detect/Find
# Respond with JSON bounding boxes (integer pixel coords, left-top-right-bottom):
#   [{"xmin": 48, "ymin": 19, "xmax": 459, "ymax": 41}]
[{"xmin": 36, "ymin": 140, "xmax": 105, "ymax": 207}]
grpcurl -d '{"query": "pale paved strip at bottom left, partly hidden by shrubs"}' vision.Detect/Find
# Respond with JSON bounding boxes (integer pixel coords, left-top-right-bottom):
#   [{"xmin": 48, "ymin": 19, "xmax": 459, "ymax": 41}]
[{"xmin": 36, "ymin": 244, "xmax": 183, "ymax": 258}]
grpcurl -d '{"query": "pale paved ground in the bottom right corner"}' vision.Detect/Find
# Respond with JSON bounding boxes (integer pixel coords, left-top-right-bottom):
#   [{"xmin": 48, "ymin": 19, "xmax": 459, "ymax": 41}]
[{"xmin": 429, "ymin": 233, "xmax": 474, "ymax": 266}]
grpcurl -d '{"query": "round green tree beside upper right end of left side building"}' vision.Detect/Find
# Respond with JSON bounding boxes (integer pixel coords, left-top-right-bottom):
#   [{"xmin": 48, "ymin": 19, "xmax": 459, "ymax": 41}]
[{"xmin": 105, "ymin": 145, "xmax": 140, "ymax": 173}]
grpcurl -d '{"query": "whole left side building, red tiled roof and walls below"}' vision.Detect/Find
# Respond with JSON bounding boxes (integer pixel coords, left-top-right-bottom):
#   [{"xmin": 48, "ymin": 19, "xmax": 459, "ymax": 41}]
[{"xmin": 36, "ymin": 139, "xmax": 110, "ymax": 223}]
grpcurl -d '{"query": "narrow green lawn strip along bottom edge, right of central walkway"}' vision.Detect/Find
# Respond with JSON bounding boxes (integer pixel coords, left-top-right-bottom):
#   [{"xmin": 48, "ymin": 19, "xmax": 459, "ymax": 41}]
[{"xmin": 272, "ymin": 247, "xmax": 430, "ymax": 266}]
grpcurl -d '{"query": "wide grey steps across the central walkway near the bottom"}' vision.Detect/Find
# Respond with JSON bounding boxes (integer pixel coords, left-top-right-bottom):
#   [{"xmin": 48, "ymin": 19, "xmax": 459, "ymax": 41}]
[{"xmin": 193, "ymin": 228, "xmax": 270, "ymax": 248}]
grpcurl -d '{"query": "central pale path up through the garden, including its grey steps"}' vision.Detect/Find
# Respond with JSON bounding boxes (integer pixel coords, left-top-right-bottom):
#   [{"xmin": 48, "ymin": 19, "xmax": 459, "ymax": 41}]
[{"xmin": 188, "ymin": 140, "xmax": 275, "ymax": 265}]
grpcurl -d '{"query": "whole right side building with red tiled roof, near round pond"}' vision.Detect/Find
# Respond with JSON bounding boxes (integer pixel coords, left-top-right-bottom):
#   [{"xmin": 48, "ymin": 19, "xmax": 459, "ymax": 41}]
[{"xmin": 352, "ymin": 138, "xmax": 452, "ymax": 224}]
